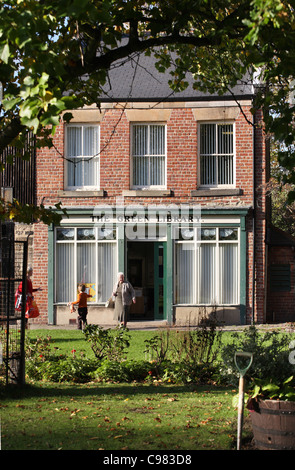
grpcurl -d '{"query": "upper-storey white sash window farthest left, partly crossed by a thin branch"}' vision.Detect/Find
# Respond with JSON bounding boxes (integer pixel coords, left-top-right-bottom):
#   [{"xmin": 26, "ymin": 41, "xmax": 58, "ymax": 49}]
[{"xmin": 66, "ymin": 124, "xmax": 99, "ymax": 189}]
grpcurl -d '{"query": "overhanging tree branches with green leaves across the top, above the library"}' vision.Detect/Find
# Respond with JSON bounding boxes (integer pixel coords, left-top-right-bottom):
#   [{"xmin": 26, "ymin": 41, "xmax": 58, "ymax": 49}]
[{"xmin": 0, "ymin": 0, "xmax": 295, "ymax": 222}]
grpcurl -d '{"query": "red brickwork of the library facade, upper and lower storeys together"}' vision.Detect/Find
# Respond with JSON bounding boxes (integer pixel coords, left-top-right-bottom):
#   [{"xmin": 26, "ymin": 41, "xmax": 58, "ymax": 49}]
[{"xmin": 34, "ymin": 106, "xmax": 265, "ymax": 322}]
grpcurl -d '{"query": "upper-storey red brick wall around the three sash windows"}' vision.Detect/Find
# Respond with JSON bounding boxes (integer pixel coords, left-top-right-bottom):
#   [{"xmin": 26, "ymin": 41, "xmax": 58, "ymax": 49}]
[{"xmin": 37, "ymin": 108, "xmax": 253, "ymax": 206}]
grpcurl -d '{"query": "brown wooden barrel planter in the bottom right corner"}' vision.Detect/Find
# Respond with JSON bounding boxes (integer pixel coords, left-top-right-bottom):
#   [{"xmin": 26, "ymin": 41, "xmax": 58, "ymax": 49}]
[{"xmin": 250, "ymin": 400, "xmax": 295, "ymax": 450}]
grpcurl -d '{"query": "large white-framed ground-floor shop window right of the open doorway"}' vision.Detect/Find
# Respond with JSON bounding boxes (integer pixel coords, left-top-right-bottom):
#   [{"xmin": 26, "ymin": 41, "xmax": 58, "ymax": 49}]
[{"xmin": 175, "ymin": 227, "xmax": 239, "ymax": 305}]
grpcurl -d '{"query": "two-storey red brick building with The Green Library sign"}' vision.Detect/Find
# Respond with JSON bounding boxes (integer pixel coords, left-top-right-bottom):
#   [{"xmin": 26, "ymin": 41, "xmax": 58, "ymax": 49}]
[{"xmin": 33, "ymin": 56, "xmax": 267, "ymax": 325}]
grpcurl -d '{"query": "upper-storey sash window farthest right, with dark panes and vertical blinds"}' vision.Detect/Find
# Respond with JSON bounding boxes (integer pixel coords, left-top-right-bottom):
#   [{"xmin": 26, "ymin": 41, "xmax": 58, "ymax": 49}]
[{"xmin": 199, "ymin": 123, "xmax": 235, "ymax": 187}]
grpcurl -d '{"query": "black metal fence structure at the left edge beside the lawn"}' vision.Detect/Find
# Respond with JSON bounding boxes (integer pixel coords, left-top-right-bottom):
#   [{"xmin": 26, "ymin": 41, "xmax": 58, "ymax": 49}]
[{"xmin": 0, "ymin": 222, "xmax": 28, "ymax": 385}]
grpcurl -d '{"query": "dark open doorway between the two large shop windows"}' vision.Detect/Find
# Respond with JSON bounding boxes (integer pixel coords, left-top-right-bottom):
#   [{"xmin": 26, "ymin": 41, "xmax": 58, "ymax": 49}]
[{"xmin": 126, "ymin": 241, "xmax": 166, "ymax": 320}]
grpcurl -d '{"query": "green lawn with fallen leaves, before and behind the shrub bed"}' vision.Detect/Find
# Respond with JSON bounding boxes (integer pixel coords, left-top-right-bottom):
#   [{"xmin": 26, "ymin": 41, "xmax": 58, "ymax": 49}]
[{"xmin": 0, "ymin": 329, "xmax": 251, "ymax": 451}]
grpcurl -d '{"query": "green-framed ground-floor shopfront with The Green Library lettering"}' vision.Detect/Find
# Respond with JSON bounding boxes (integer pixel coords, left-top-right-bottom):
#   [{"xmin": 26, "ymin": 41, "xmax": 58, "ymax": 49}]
[{"xmin": 48, "ymin": 205, "xmax": 249, "ymax": 325}]
